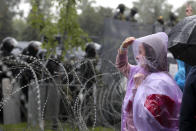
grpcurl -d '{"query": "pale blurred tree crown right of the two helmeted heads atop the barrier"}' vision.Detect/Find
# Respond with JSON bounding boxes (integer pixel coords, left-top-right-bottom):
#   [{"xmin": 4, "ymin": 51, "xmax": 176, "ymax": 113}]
[{"xmin": 133, "ymin": 0, "xmax": 172, "ymax": 24}]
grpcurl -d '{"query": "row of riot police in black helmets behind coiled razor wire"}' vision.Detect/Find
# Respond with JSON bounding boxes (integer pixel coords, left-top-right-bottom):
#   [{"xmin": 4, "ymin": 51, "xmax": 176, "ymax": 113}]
[{"xmin": 0, "ymin": 37, "xmax": 100, "ymax": 126}]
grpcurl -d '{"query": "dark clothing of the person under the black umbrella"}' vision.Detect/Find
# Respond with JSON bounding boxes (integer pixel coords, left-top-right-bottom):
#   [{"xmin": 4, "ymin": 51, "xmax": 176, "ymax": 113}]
[{"xmin": 180, "ymin": 66, "xmax": 196, "ymax": 131}]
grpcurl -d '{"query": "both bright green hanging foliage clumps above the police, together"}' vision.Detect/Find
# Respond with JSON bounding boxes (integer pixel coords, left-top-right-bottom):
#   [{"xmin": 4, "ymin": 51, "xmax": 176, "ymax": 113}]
[{"xmin": 25, "ymin": 0, "xmax": 88, "ymax": 54}]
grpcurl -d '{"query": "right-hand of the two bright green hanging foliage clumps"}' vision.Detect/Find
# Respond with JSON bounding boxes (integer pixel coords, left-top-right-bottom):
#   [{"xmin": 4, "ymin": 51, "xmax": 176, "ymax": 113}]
[{"xmin": 58, "ymin": 0, "xmax": 88, "ymax": 53}]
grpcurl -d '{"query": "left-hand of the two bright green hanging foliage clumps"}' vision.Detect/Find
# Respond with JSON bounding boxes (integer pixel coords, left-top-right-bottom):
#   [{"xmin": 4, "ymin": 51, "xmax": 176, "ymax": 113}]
[{"xmin": 27, "ymin": 0, "xmax": 58, "ymax": 53}]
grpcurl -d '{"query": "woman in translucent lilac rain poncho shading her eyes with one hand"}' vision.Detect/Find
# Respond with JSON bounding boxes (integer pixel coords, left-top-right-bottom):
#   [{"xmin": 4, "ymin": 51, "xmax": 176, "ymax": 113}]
[{"xmin": 116, "ymin": 32, "xmax": 182, "ymax": 131}]
